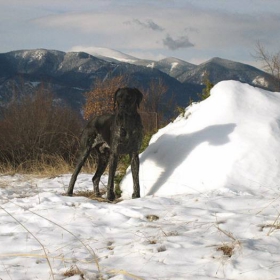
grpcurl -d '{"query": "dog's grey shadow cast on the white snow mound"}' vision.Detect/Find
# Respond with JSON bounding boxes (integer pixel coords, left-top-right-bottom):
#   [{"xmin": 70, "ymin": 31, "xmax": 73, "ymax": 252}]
[{"xmin": 140, "ymin": 123, "xmax": 236, "ymax": 195}]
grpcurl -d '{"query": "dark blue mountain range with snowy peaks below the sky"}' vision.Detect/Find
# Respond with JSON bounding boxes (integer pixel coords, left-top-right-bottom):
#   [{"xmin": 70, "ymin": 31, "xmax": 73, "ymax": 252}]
[{"xmin": 0, "ymin": 48, "xmax": 274, "ymax": 110}]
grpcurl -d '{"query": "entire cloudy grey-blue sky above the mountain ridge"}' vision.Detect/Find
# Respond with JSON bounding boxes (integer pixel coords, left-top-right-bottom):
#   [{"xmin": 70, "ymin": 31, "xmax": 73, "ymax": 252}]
[{"xmin": 0, "ymin": 0, "xmax": 280, "ymax": 67}]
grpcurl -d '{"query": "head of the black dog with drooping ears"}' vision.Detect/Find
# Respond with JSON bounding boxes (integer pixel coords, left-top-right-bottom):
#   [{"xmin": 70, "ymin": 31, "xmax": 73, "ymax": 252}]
[{"xmin": 114, "ymin": 88, "xmax": 143, "ymax": 114}]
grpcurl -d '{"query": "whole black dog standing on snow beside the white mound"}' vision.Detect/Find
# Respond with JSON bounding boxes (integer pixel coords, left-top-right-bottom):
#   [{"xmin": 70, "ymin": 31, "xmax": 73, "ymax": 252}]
[{"xmin": 67, "ymin": 87, "xmax": 143, "ymax": 201}]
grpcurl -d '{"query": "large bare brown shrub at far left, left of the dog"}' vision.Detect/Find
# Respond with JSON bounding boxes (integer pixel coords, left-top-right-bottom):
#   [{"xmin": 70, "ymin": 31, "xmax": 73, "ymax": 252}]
[{"xmin": 0, "ymin": 89, "xmax": 81, "ymax": 170}]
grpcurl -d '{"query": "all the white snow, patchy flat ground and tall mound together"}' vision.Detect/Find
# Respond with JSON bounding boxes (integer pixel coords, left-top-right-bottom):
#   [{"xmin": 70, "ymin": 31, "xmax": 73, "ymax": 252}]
[{"xmin": 0, "ymin": 81, "xmax": 280, "ymax": 280}]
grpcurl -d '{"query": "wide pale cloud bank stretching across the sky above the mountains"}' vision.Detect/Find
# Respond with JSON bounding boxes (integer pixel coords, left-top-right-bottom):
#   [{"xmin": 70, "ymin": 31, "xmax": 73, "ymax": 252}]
[{"xmin": 29, "ymin": 3, "xmax": 280, "ymax": 52}]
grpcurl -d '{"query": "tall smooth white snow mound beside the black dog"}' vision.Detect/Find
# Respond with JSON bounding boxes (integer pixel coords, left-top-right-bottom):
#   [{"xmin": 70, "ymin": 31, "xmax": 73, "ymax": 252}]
[{"xmin": 121, "ymin": 81, "xmax": 280, "ymax": 199}]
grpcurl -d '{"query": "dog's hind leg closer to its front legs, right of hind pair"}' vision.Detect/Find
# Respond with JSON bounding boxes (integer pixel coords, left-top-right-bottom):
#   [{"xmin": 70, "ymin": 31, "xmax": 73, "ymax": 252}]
[{"xmin": 92, "ymin": 149, "xmax": 110, "ymax": 196}]
